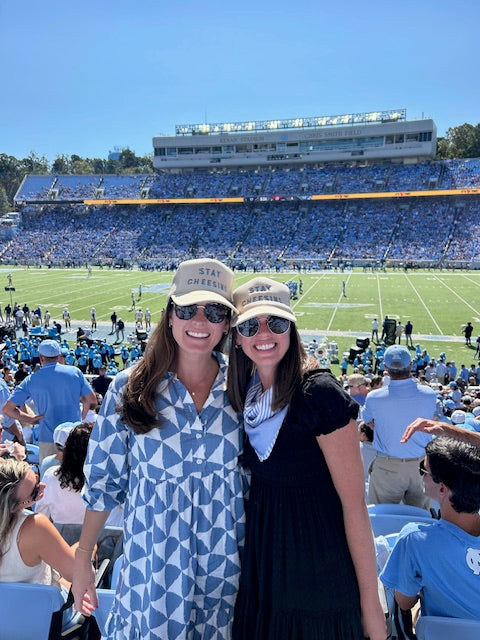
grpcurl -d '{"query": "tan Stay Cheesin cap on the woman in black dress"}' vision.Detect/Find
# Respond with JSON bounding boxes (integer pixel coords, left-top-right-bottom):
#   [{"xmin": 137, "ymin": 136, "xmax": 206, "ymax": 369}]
[{"xmin": 233, "ymin": 277, "xmax": 297, "ymax": 327}]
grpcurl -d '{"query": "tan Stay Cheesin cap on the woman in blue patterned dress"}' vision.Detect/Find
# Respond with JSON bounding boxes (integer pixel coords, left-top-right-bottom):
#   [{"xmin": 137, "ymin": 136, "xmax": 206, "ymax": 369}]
[{"xmin": 168, "ymin": 258, "xmax": 235, "ymax": 311}]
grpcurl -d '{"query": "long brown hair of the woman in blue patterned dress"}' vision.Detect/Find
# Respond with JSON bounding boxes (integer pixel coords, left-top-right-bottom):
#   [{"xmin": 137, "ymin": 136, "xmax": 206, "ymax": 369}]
[{"xmin": 122, "ymin": 299, "xmax": 231, "ymax": 433}]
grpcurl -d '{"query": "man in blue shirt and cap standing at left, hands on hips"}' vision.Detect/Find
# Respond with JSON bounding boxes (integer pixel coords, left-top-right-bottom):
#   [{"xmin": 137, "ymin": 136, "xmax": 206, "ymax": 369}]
[{"xmin": 2, "ymin": 340, "xmax": 97, "ymax": 462}]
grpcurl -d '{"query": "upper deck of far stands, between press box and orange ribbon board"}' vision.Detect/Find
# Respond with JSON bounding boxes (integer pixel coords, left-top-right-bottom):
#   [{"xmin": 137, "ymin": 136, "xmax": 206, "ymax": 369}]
[{"xmin": 15, "ymin": 159, "xmax": 480, "ymax": 208}]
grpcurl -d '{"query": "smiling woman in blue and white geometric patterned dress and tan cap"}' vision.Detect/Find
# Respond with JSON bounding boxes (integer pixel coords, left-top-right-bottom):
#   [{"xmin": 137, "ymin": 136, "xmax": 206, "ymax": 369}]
[{"xmin": 73, "ymin": 259, "xmax": 251, "ymax": 640}]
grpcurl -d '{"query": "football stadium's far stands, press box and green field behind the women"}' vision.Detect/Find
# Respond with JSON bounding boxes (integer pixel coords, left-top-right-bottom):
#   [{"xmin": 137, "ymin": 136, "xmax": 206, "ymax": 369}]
[{"xmin": 5, "ymin": 109, "xmax": 480, "ymax": 372}]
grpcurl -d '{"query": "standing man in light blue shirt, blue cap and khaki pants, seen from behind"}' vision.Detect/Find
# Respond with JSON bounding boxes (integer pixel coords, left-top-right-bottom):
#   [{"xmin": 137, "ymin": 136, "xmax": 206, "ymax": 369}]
[{"xmin": 362, "ymin": 345, "xmax": 437, "ymax": 508}]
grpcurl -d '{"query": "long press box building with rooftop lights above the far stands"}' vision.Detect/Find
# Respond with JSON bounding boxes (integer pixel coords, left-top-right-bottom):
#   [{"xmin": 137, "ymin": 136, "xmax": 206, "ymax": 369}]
[{"xmin": 153, "ymin": 109, "xmax": 437, "ymax": 170}]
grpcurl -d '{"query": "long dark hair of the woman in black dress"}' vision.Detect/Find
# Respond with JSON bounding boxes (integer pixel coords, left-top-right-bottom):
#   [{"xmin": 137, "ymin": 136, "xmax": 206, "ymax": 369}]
[{"xmin": 227, "ymin": 322, "xmax": 310, "ymax": 413}]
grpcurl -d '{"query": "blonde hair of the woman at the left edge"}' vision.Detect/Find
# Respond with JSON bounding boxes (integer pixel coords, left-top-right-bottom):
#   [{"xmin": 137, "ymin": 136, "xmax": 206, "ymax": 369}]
[{"xmin": 0, "ymin": 458, "xmax": 30, "ymax": 562}]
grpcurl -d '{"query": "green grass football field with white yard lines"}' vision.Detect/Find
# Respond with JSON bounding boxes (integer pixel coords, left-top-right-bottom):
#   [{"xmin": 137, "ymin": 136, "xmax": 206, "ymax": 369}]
[{"xmin": 0, "ymin": 267, "xmax": 480, "ymax": 373}]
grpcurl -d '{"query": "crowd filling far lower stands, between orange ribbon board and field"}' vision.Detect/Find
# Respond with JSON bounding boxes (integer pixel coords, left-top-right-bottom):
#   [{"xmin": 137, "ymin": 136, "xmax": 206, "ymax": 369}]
[{"xmin": 0, "ymin": 197, "xmax": 480, "ymax": 269}]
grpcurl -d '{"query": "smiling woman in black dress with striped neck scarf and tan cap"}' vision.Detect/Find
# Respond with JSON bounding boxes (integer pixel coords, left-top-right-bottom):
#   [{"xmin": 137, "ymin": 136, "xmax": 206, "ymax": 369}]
[{"xmin": 228, "ymin": 277, "xmax": 386, "ymax": 640}]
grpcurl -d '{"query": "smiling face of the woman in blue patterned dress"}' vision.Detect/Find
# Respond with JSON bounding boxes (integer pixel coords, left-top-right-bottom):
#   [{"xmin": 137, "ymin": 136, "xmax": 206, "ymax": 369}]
[{"xmin": 169, "ymin": 300, "xmax": 229, "ymax": 356}]
